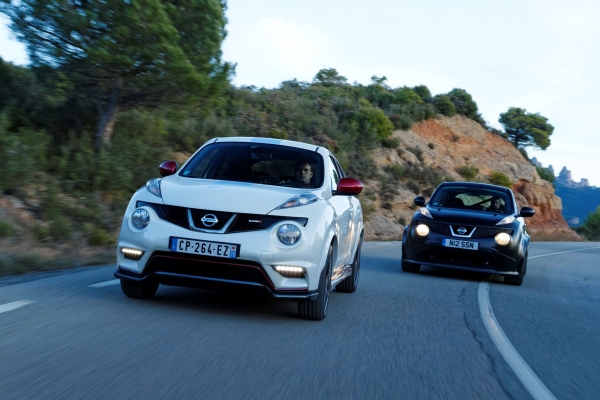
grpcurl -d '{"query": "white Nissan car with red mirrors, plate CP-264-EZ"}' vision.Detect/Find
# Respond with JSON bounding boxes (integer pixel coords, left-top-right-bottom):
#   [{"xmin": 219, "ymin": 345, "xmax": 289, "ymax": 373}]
[{"xmin": 115, "ymin": 137, "xmax": 363, "ymax": 320}]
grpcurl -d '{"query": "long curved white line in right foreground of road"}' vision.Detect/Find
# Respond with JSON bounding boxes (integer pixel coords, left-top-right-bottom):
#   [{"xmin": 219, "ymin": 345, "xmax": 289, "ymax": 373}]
[{"xmin": 477, "ymin": 281, "xmax": 556, "ymax": 400}]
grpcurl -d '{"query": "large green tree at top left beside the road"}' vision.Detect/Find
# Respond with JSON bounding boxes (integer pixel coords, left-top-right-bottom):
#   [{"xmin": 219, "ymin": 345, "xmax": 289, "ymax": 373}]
[{"xmin": 0, "ymin": 0, "xmax": 232, "ymax": 150}]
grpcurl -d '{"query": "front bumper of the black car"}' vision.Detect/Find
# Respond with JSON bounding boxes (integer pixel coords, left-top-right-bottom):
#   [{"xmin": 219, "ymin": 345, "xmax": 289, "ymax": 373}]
[{"xmin": 404, "ymin": 229, "xmax": 520, "ymax": 275}]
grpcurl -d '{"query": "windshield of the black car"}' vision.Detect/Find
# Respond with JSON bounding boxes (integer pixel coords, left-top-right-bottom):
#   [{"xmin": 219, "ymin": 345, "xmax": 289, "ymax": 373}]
[{"xmin": 429, "ymin": 186, "xmax": 514, "ymax": 214}]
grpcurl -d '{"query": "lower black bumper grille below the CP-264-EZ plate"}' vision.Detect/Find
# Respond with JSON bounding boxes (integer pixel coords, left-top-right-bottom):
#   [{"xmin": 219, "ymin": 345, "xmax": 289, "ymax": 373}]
[{"xmin": 144, "ymin": 251, "xmax": 273, "ymax": 288}]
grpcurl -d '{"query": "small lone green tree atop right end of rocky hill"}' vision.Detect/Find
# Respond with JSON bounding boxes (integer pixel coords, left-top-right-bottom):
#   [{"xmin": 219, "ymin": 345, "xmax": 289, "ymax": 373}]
[{"xmin": 498, "ymin": 107, "xmax": 554, "ymax": 150}]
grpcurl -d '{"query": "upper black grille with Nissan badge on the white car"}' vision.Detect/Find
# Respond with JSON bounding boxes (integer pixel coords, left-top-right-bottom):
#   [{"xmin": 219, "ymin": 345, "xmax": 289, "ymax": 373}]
[{"xmin": 136, "ymin": 201, "xmax": 308, "ymax": 233}]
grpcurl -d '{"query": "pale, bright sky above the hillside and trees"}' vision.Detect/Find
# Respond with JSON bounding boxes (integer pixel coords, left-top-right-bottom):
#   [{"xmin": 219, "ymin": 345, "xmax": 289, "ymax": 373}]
[{"xmin": 0, "ymin": 0, "xmax": 600, "ymax": 187}]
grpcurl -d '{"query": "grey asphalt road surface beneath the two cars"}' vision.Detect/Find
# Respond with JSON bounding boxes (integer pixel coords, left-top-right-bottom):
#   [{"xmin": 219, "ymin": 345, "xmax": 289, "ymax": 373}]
[{"xmin": 0, "ymin": 242, "xmax": 600, "ymax": 399}]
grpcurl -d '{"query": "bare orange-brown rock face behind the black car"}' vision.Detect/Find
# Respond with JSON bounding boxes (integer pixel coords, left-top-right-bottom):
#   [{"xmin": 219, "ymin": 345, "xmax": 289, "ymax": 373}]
[{"xmin": 361, "ymin": 115, "xmax": 581, "ymax": 241}]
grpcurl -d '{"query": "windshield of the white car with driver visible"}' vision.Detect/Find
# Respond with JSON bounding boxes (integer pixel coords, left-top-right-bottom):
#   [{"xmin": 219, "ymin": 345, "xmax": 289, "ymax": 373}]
[{"xmin": 179, "ymin": 142, "xmax": 323, "ymax": 188}]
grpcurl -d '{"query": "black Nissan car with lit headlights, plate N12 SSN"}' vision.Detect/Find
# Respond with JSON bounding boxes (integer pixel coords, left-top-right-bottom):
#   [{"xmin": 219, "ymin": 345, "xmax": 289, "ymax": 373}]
[{"xmin": 402, "ymin": 182, "xmax": 535, "ymax": 286}]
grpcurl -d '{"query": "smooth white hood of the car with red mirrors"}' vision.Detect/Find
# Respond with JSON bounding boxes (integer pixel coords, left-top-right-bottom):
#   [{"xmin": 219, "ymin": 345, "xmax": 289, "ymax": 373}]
[{"xmin": 160, "ymin": 175, "xmax": 309, "ymax": 215}]
